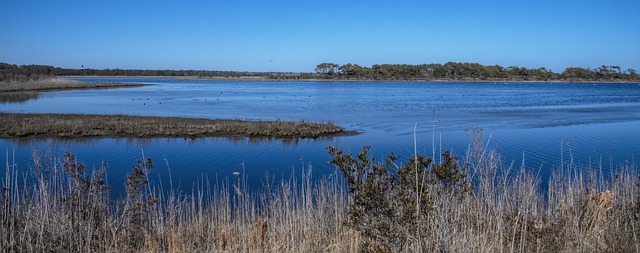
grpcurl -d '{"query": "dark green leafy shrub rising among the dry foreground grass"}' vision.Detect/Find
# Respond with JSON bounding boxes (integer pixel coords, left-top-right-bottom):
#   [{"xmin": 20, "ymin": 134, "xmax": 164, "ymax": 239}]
[{"xmin": 327, "ymin": 146, "xmax": 471, "ymax": 252}]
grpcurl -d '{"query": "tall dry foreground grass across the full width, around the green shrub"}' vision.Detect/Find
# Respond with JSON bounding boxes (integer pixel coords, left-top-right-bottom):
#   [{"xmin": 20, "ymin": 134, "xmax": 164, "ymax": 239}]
[{"xmin": 0, "ymin": 138, "xmax": 640, "ymax": 252}]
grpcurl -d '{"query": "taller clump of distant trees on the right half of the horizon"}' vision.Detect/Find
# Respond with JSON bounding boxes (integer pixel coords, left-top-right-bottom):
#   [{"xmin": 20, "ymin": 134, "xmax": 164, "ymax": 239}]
[{"xmin": 315, "ymin": 62, "xmax": 640, "ymax": 81}]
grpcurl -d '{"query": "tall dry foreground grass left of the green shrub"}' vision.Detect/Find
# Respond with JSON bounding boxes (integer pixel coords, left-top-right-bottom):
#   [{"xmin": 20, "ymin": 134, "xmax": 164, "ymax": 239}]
[{"xmin": 0, "ymin": 151, "xmax": 358, "ymax": 252}]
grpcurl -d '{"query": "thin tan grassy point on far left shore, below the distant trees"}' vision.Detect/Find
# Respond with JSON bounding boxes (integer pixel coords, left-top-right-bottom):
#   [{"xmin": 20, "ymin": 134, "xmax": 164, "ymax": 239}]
[{"xmin": 0, "ymin": 78, "xmax": 144, "ymax": 92}]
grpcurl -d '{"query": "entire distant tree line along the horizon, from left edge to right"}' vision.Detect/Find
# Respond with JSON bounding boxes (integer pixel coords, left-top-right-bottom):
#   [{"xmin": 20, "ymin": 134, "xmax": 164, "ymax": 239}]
[{"xmin": 0, "ymin": 62, "xmax": 640, "ymax": 81}]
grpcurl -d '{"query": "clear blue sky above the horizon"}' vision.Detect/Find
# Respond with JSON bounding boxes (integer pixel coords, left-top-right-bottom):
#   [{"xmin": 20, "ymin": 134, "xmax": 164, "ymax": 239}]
[{"xmin": 0, "ymin": 0, "xmax": 640, "ymax": 72}]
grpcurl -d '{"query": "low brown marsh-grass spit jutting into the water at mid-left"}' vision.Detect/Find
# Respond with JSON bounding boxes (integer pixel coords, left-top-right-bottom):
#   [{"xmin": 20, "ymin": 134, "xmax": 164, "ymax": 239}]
[{"xmin": 0, "ymin": 113, "xmax": 347, "ymax": 138}]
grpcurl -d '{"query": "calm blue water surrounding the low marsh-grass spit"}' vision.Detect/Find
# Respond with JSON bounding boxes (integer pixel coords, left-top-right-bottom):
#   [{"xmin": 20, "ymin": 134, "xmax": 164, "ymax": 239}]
[{"xmin": 0, "ymin": 79, "xmax": 640, "ymax": 196}]
